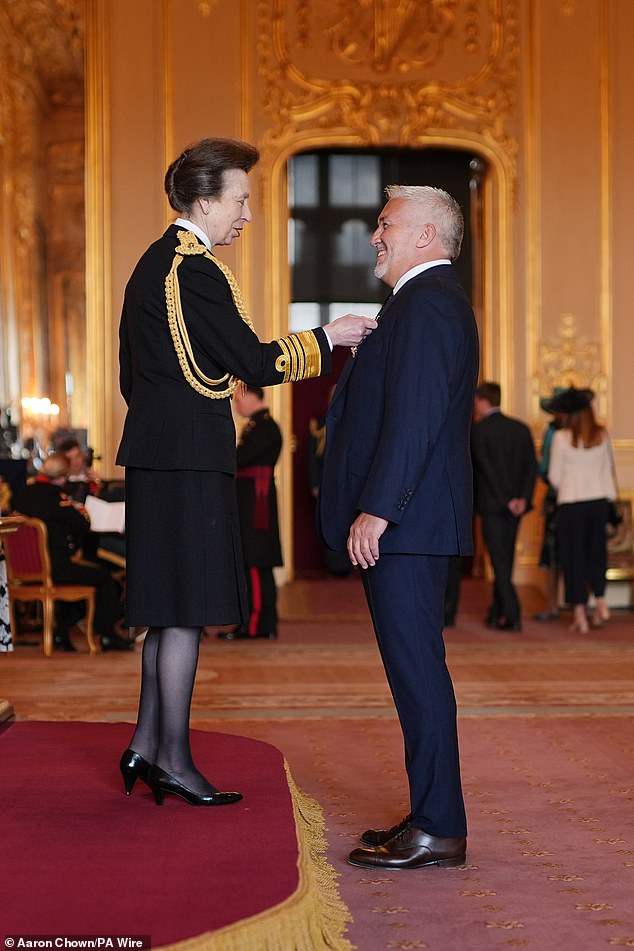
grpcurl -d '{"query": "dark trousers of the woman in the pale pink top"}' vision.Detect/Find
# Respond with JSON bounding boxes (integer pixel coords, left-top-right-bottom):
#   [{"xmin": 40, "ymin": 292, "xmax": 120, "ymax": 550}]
[{"xmin": 557, "ymin": 499, "xmax": 608, "ymax": 604}]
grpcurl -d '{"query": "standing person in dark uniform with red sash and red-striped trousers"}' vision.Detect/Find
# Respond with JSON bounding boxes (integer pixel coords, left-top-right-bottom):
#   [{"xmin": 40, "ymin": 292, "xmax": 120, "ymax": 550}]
[{"xmin": 218, "ymin": 386, "xmax": 284, "ymax": 641}]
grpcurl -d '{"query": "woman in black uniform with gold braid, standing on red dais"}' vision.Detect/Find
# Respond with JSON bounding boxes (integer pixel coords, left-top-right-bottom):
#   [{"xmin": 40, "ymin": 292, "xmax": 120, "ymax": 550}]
[{"xmin": 117, "ymin": 139, "xmax": 375, "ymax": 806}]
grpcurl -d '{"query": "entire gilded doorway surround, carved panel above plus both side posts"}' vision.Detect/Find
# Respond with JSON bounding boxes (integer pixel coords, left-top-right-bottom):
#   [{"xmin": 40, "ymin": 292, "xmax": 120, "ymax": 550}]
[{"xmin": 243, "ymin": 0, "xmax": 520, "ymax": 561}]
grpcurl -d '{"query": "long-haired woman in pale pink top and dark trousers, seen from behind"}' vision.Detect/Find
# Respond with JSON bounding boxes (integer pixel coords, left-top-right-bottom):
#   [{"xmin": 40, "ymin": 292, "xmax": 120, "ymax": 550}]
[{"xmin": 548, "ymin": 387, "xmax": 616, "ymax": 634}]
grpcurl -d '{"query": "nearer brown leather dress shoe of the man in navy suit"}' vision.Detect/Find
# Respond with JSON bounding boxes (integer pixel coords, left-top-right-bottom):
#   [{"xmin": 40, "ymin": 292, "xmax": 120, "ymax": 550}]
[{"xmin": 348, "ymin": 824, "xmax": 467, "ymax": 869}]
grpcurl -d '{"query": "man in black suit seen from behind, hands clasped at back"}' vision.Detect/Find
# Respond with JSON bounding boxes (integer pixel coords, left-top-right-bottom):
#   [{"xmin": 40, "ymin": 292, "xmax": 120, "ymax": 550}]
[{"xmin": 471, "ymin": 382, "xmax": 537, "ymax": 631}]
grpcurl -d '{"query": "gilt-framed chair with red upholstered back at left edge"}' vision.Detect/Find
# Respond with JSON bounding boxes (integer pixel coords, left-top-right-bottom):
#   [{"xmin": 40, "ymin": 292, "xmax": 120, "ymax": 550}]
[{"xmin": 4, "ymin": 518, "xmax": 97, "ymax": 657}]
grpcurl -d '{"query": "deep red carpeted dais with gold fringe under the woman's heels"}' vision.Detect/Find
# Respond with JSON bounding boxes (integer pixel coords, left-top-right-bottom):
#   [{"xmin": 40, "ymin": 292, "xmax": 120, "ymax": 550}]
[{"xmin": 0, "ymin": 722, "xmax": 349, "ymax": 951}]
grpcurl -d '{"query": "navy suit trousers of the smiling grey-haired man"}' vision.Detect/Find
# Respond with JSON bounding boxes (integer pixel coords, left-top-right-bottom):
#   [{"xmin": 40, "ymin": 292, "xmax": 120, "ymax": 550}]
[{"xmin": 361, "ymin": 554, "xmax": 466, "ymax": 838}]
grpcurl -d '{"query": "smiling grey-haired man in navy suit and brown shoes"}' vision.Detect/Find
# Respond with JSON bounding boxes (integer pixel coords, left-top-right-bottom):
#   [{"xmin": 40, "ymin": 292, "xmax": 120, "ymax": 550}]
[{"xmin": 319, "ymin": 185, "xmax": 478, "ymax": 868}]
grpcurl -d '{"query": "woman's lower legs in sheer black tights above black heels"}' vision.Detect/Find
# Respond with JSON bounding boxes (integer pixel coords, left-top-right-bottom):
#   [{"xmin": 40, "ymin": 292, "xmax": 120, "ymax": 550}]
[{"xmin": 130, "ymin": 627, "xmax": 217, "ymax": 795}]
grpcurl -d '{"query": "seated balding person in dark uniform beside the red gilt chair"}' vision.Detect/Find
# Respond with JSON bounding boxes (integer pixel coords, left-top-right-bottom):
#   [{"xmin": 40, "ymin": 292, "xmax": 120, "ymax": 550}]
[{"xmin": 13, "ymin": 452, "xmax": 134, "ymax": 651}]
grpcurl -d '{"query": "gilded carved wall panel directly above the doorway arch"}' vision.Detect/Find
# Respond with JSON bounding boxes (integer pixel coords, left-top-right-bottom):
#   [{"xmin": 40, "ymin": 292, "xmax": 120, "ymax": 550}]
[{"xmin": 257, "ymin": 0, "xmax": 518, "ymax": 170}]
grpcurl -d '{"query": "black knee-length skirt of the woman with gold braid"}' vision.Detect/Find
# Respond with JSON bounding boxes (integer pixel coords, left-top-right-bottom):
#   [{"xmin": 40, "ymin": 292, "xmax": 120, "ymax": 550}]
[{"xmin": 126, "ymin": 468, "xmax": 249, "ymax": 627}]
